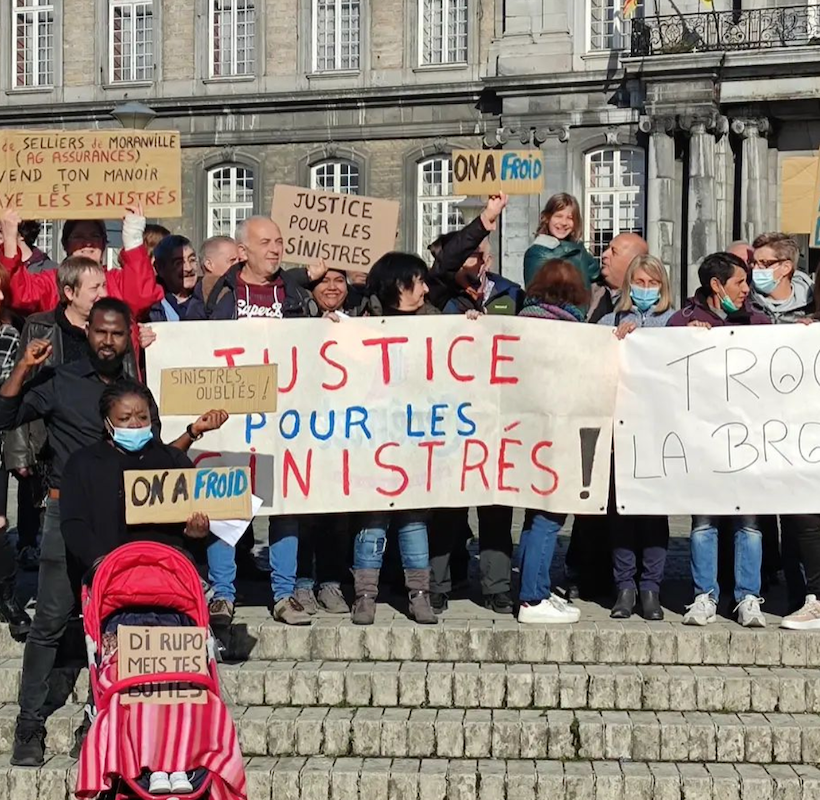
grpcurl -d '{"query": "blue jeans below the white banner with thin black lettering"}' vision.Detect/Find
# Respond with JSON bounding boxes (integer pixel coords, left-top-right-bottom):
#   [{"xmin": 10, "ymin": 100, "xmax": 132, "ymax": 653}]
[{"xmin": 689, "ymin": 515, "xmax": 763, "ymax": 603}]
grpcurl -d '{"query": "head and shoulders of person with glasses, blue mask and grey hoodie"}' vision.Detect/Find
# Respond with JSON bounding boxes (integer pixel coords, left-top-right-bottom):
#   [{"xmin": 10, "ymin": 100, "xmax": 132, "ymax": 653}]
[{"xmin": 749, "ymin": 233, "xmax": 814, "ymax": 324}]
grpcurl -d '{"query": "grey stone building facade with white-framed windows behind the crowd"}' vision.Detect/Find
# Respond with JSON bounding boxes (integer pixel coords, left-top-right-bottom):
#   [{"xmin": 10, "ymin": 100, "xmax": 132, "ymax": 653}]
[{"xmin": 0, "ymin": 0, "xmax": 820, "ymax": 294}]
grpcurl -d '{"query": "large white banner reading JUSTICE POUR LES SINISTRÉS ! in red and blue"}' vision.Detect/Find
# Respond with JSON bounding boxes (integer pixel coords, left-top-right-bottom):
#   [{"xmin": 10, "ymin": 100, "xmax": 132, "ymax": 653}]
[{"xmin": 147, "ymin": 316, "xmax": 617, "ymax": 514}]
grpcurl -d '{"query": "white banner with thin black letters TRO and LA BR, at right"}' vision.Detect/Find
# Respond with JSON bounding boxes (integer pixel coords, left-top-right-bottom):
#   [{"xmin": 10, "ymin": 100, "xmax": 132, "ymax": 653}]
[{"xmin": 615, "ymin": 324, "xmax": 820, "ymax": 514}]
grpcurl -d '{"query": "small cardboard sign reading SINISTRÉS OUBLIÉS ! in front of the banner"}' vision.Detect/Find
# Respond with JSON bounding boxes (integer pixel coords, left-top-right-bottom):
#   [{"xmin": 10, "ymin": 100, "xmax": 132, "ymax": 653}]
[{"xmin": 160, "ymin": 364, "xmax": 276, "ymax": 416}]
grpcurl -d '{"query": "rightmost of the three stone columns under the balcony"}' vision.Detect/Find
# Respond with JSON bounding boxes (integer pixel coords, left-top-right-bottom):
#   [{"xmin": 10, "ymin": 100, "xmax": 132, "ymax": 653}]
[{"xmin": 732, "ymin": 119, "xmax": 770, "ymax": 244}]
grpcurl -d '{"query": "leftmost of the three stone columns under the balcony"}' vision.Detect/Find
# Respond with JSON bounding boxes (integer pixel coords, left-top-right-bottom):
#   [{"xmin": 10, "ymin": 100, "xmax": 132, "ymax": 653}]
[{"xmin": 640, "ymin": 117, "xmax": 682, "ymax": 308}]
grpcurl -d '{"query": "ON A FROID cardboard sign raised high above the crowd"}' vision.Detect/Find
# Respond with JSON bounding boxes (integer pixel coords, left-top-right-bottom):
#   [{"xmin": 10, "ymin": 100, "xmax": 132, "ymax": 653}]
[{"xmin": 453, "ymin": 150, "xmax": 544, "ymax": 195}]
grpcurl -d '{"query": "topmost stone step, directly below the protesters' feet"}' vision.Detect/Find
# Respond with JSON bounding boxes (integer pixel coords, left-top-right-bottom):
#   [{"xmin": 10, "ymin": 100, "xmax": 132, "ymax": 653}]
[{"xmin": 0, "ymin": 601, "xmax": 820, "ymax": 667}]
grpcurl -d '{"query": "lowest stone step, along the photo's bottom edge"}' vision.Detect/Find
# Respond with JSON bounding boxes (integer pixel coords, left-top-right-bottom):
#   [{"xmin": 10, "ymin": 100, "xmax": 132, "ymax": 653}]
[{"xmin": 0, "ymin": 756, "xmax": 820, "ymax": 800}]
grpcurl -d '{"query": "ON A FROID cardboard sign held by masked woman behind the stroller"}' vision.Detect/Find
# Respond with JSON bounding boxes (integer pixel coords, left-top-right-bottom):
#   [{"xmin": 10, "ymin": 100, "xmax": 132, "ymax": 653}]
[{"xmin": 123, "ymin": 467, "xmax": 251, "ymax": 525}]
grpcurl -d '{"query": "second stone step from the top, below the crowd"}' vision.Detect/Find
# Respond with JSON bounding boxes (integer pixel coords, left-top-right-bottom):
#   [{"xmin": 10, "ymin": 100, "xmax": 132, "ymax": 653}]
[{"xmin": 0, "ymin": 659, "xmax": 820, "ymax": 714}]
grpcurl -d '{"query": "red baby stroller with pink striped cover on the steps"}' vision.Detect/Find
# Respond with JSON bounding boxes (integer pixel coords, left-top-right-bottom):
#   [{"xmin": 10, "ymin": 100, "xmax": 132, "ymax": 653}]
[{"xmin": 75, "ymin": 542, "xmax": 247, "ymax": 800}]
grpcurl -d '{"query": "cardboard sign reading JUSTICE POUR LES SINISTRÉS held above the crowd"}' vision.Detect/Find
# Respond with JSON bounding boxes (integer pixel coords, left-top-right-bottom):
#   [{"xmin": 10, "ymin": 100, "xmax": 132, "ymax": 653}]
[{"xmin": 271, "ymin": 183, "xmax": 399, "ymax": 272}]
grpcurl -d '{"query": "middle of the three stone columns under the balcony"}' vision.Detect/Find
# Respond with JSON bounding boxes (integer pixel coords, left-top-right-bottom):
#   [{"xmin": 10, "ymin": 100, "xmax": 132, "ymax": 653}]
[{"xmin": 681, "ymin": 114, "xmax": 723, "ymax": 294}]
